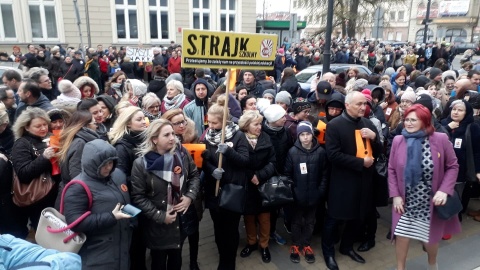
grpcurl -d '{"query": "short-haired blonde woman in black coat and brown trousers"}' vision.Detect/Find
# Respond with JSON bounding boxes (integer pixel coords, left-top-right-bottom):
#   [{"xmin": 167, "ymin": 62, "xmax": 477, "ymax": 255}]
[{"xmin": 238, "ymin": 111, "xmax": 276, "ymax": 263}]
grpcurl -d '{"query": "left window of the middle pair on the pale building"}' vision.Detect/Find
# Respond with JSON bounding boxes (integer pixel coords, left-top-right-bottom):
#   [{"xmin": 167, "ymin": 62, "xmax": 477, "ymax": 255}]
[{"xmin": 115, "ymin": 0, "xmax": 138, "ymax": 39}]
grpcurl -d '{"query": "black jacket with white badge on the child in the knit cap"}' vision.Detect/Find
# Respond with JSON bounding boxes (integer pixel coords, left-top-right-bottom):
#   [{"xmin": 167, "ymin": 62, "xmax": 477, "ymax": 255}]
[{"xmin": 285, "ymin": 137, "xmax": 328, "ymax": 206}]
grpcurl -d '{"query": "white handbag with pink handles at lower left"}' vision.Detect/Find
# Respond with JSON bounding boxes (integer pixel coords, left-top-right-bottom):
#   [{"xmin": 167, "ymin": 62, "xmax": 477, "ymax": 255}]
[{"xmin": 35, "ymin": 180, "xmax": 92, "ymax": 253}]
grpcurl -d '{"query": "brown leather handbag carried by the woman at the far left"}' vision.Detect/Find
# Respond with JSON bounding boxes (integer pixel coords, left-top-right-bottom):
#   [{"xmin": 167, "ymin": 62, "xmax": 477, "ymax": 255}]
[{"xmin": 12, "ymin": 145, "xmax": 55, "ymax": 207}]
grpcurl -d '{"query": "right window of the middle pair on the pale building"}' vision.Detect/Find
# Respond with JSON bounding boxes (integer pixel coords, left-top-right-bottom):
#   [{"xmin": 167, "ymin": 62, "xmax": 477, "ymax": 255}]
[{"xmin": 149, "ymin": 0, "xmax": 168, "ymax": 39}]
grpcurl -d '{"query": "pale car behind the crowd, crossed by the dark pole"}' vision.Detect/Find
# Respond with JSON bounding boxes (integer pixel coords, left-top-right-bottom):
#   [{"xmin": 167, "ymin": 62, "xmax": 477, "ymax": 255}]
[{"xmin": 295, "ymin": 64, "xmax": 372, "ymax": 97}]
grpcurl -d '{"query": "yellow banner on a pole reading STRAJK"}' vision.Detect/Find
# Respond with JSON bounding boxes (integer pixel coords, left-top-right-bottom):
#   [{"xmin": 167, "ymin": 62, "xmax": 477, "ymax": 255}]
[{"xmin": 182, "ymin": 29, "xmax": 278, "ymax": 70}]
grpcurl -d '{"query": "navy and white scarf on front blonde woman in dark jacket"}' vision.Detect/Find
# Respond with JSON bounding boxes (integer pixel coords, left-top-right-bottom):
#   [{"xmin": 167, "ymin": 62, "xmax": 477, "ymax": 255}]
[{"xmin": 144, "ymin": 149, "xmax": 183, "ymax": 206}]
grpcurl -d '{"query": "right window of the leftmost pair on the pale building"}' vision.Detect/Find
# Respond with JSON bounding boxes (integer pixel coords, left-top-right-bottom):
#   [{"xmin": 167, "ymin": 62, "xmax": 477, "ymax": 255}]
[{"xmin": 28, "ymin": 0, "xmax": 58, "ymax": 40}]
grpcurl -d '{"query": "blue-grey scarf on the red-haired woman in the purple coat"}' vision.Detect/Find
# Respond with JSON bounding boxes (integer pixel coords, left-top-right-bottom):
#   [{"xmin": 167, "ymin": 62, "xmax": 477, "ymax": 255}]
[{"xmin": 402, "ymin": 129, "xmax": 427, "ymax": 187}]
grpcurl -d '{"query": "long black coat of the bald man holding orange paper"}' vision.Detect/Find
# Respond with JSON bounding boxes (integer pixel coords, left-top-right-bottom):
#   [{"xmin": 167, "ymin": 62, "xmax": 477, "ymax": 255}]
[{"xmin": 325, "ymin": 112, "xmax": 382, "ymax": 220}]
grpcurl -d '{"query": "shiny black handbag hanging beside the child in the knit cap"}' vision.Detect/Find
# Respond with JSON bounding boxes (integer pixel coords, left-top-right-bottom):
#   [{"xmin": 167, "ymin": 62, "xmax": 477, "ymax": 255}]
[{"xmin": 258, "ymin": 175, "xmax": 293, "ymax": 207}]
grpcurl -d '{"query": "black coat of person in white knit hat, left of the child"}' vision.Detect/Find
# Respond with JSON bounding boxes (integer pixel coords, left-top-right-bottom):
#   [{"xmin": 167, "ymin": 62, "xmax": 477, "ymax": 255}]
[{"xmin": 262, "ymin": 123, "xmax": 294, "ymax": 175}]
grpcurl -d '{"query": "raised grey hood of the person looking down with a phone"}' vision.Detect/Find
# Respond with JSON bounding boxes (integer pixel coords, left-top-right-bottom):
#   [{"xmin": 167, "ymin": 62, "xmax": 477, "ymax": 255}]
[{"xmin": 82, "ymin": 139, "xmax": 118, "ymax": 180}]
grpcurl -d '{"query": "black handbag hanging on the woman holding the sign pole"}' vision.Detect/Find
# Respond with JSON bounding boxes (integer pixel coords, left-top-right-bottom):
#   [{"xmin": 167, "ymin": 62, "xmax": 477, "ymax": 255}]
[{"xmin": 219, "ymin": 184, "xmax": 247, "ymax": 213}]
